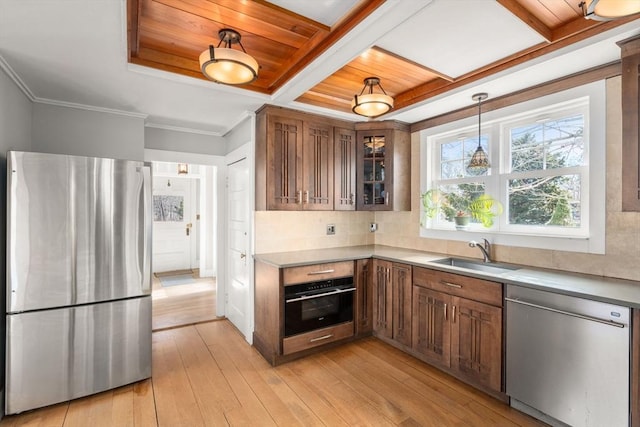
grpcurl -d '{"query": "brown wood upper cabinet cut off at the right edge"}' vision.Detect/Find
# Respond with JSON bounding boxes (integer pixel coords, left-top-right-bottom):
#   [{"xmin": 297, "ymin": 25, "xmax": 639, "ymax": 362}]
[{"xmin": 618, "ymin": 36, "xmax": 640, "ymax": 211}]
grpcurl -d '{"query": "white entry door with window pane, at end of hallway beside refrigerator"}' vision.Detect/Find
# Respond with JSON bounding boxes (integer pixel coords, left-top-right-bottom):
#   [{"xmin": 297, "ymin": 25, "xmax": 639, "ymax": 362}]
[{"xmin": 153, "ymin": 177, "xmax": 195, "ymax": 272}]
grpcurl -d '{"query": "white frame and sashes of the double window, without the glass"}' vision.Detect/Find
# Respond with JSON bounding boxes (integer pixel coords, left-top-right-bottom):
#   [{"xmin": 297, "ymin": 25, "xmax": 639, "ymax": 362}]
[{"xmin": 420, "ymin": 80, "xmax": 606, "ymax": 254}]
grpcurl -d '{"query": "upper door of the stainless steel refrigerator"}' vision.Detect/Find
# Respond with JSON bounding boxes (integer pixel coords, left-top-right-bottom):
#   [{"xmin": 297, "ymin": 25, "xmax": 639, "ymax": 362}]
[{"xmin": 7, "ymin": 152, "xmax": 151, "ymax": 312}]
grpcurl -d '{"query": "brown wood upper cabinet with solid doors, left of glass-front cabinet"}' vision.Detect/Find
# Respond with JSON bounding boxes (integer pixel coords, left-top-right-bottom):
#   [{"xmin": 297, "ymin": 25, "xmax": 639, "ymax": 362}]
[{"xmin": 256, "ymin": 106, "xmax": 356, "ymax": 210}]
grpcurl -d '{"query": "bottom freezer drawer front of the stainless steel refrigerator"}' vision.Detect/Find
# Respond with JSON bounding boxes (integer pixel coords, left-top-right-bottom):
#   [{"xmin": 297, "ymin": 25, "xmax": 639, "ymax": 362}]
[{"xmin": 5, "ymin": 296, "xmax": 151, "ymax": 414}]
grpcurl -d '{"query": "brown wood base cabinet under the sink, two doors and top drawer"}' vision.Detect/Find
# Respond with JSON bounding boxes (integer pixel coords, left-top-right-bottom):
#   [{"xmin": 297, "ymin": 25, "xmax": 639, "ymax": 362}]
[{"xmin": 412, "ymin": 267, "xmax": 502, "ymax": 393}]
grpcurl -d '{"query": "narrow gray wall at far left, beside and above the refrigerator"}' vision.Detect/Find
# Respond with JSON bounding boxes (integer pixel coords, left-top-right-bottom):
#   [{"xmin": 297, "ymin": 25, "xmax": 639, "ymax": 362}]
[{"xmin": 0, "ymin": 69, "xmax": 33, "ymax": 418}]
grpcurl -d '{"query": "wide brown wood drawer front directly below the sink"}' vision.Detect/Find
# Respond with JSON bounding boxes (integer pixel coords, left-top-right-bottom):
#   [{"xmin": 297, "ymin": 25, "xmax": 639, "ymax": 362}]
[{"xmin": 413, "ymin": 267, "xmax": 502, "ymax": 307}]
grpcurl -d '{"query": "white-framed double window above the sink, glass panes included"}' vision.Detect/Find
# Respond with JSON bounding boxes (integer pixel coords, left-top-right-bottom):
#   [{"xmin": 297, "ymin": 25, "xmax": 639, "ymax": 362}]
[{"xmin": 421, "ymin": 82, "xmax": 605, "ymax": 253}]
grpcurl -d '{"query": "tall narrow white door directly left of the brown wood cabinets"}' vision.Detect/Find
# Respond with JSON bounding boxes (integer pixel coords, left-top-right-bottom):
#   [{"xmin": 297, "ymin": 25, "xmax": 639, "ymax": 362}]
[{"xmin": 225, "ymin": 158, "xmax": 251, "ymax": 338}]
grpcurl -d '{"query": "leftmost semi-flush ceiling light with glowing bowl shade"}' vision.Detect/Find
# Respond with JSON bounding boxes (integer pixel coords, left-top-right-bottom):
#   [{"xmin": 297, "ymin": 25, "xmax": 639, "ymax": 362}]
[{"xmin": 200, "ymin": 28, "xmax": 258, "ymax": 85}]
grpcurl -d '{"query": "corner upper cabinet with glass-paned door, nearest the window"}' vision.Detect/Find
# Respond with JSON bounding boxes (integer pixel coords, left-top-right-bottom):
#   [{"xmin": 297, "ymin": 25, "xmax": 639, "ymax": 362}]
[{"xmin": 356, "ymin": 122, "xmax": 411, "ymax": 211}]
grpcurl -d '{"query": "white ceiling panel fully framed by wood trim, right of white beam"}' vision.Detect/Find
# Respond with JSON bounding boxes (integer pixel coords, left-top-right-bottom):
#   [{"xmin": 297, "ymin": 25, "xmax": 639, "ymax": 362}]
[{"xmin": 376, "ymin": 0, "xmax": 544, "ymax": 78}]
